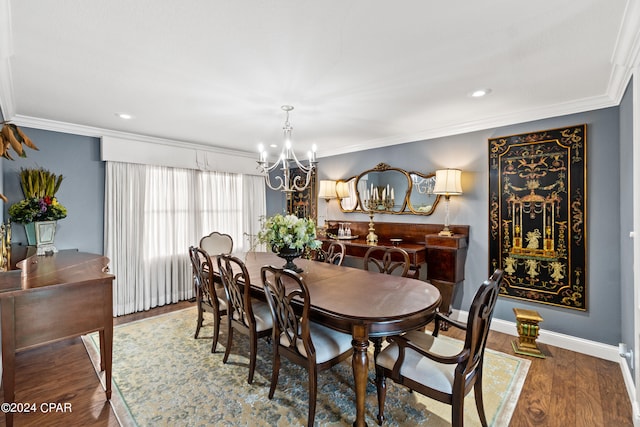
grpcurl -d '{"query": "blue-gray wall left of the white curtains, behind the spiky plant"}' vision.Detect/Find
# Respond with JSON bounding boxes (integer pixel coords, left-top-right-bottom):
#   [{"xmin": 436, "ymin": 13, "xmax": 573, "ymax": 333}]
[{"xmin": 2, "ymin": 127, "xmax": 105, "ymax": 254}]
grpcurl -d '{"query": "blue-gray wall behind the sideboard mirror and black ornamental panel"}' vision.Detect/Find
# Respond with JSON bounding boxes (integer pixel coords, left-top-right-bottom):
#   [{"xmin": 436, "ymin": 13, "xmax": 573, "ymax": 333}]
[{"xmin": 302, "ymin": 108, "xmax": 632, "ymax": 345}]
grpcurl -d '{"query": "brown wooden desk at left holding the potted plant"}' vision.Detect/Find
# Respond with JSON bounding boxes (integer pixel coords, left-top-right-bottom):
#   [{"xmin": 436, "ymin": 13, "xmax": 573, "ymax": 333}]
[{"xmin": 0, "ymin": 251, "xmax": 114, "ymax": 426}]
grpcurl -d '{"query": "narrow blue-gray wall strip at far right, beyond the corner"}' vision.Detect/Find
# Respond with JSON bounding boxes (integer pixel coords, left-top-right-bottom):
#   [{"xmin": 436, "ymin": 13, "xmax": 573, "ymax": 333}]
[{"xmin": 620, "ymin": 77, "xmax": 635, "ymax": 378}]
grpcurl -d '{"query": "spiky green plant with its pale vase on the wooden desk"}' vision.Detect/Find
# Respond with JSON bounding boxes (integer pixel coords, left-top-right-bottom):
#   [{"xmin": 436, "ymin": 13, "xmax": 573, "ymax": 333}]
[{"xmin": 9, "ymin": 168, "xmax": 67, "ymax": 254}]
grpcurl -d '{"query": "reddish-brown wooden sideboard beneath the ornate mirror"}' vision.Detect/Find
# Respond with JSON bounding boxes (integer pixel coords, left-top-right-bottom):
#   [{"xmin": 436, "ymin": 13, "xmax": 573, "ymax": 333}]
[{"xmin": 319, "ymin": 220, "xmax": 469, "ymax": 314}]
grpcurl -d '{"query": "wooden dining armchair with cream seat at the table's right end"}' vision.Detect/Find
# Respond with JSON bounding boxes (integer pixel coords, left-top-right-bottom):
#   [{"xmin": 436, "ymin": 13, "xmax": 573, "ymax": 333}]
[{"xmin": 376, "ymin": 270, "xmax": 502, "ymax": 427}]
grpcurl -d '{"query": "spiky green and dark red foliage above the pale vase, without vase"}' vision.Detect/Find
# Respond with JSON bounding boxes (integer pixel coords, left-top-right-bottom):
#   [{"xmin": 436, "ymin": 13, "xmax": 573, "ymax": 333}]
[{"xmin": 9, "ymin": 168, "xmax": 67, "ymax": 224}]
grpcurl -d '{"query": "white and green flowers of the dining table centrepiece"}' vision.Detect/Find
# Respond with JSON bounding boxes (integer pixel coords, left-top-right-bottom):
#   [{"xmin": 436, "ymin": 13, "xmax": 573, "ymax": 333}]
[{"xmin": 258, "ymin": 214, "xmax": 321, "ymax": 252}]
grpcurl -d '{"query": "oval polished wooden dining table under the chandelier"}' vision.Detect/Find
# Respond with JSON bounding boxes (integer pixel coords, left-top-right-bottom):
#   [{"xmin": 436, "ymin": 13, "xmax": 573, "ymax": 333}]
[{"xmin": 239, "ymin": 252, "xmax": 440, "ymax": 427}]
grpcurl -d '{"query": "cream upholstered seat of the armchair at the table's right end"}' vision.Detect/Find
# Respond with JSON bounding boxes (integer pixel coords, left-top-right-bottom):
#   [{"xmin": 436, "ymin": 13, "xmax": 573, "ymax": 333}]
[{"xmin": 376, "ymin": 331, "xmax": 464, "ymax": 394}]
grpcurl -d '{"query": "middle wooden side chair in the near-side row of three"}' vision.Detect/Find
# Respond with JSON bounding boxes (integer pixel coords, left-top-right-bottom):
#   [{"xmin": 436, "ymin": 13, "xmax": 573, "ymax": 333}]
[{"xmin": 217, "ymin": 254, "xmax": 273, "ymax": 384}]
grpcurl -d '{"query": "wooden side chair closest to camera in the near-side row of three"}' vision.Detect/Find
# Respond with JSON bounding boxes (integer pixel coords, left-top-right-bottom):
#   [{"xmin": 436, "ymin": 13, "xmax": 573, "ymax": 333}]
[{"xmin": 260, "ymin": 266, "xmax": 353, "ymax": 426}]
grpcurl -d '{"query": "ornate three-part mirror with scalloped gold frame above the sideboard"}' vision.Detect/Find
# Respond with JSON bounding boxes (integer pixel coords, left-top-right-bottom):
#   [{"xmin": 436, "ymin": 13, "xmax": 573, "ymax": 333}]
[{"xmin": 337, "ymin": 163, "xmax": 440, "ymax": 215}]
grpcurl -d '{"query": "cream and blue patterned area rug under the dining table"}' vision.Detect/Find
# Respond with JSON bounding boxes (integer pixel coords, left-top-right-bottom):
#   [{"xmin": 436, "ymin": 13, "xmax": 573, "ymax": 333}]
[{"xmin": 83, "ymin": 308, "xmax": 530, "ymax": 427}]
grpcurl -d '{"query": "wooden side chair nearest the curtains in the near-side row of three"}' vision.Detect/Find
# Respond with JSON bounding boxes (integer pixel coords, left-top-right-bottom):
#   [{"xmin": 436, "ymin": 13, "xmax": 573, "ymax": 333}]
[{"xmin": 189, "ymin": 246, "xmax": 227, "ymax": 353}]
